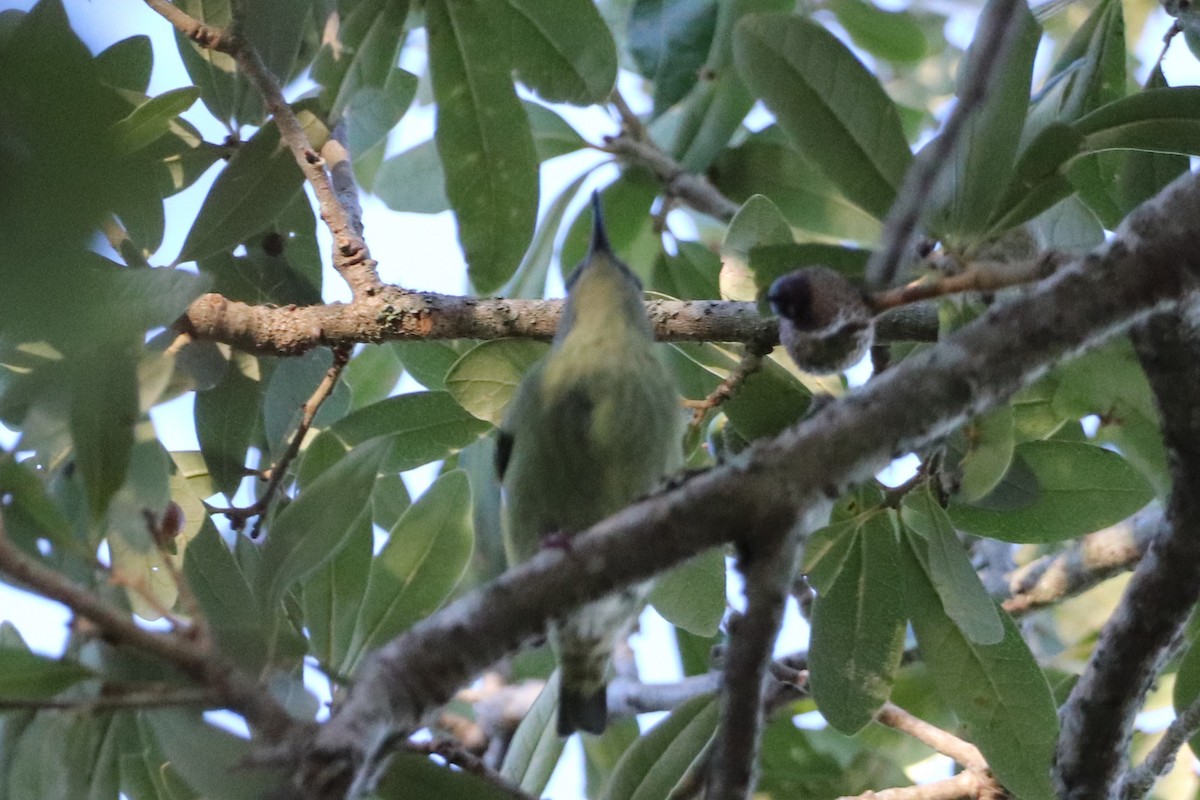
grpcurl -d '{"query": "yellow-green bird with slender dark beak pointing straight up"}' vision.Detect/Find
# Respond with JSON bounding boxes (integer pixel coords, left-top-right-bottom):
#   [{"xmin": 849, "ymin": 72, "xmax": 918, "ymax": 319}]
[{"xmin": 497, "ymin": 194, "xmax": 683, "ymax": 736}]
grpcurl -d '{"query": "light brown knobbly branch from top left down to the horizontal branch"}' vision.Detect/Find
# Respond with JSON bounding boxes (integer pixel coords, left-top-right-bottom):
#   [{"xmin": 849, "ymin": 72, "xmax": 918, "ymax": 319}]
[{"xmin": 145, "ymin": 0, "xmax": 383, "ymax": 299}]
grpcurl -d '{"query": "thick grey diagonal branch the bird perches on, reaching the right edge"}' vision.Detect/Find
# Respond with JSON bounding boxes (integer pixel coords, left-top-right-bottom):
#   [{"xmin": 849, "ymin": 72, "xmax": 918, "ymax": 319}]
[{"xmin": 298, "ymin": 175, "xmax": 1200, "ymax": 798}]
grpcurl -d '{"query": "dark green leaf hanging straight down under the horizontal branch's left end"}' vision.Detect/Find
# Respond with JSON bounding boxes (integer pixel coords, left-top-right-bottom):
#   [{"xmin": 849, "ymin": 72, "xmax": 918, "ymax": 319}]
[{"xmin": 194, "ymin": 353, "xmax": 259, "ymax": 498}]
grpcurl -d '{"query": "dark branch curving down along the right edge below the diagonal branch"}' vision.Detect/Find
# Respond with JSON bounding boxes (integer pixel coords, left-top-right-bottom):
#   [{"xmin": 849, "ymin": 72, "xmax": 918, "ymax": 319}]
[{"xmin": 1055, "ymin": 302, "xmax": 1200, "ymax": 800}]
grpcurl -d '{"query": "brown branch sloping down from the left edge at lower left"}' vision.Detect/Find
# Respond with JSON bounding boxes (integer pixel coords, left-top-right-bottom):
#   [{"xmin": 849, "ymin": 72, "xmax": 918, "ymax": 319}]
[{"xmin": 0, "ymin": 516, "xmax": 296, "ymax": 741}]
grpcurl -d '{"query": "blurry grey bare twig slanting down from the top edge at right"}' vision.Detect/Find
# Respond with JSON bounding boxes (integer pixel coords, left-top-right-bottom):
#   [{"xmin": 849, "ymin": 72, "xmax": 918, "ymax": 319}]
[{"xmin": 866, "ymin": 0, "xmax": 1028, "ymax": 291}]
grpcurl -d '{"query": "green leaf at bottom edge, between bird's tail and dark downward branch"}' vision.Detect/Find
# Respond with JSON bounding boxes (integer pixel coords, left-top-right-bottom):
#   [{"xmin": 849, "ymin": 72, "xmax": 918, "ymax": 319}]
[{"xmin": 600, "ymin": 694, "xmax": 718, "ymax": 800}]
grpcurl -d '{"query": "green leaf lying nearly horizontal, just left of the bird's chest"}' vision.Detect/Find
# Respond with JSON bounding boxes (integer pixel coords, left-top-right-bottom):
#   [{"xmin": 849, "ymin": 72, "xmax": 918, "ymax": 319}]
[{"xmin": 300, "ymin": 392, "xmax": 492, "ymax": 483}]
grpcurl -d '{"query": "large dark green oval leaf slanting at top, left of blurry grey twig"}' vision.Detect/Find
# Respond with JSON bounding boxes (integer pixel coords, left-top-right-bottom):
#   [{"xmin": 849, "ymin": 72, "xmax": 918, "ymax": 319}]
[{"xmin": 733, "ymin": 14, "xmax": 912, "ymax": 218}]
